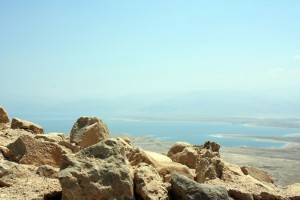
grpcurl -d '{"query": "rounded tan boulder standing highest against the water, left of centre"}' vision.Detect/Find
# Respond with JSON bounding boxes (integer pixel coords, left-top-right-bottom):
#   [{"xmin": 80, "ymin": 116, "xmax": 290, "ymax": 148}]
[{"xmin": 70, "ymin": 117, "xmax": 109, "ymax": 148}]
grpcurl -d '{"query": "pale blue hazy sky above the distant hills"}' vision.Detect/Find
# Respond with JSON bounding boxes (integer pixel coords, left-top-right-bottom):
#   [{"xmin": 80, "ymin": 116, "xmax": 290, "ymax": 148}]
[{"xmin": 0, "ymin": 0, "xmax": 300, "ymax": 99}]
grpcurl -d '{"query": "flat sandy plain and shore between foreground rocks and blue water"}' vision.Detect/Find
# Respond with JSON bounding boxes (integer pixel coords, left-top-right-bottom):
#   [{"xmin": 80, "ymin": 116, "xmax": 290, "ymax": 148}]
[{"xmin": 119, "ymin": 135, "xmax": 300, "ymax": 186}]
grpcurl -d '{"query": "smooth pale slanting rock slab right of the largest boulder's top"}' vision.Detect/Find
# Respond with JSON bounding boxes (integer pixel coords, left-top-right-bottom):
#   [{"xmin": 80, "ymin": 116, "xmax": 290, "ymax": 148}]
[{"xmin": 128, "ymin": 148, "xmax": 195, "ymax": 182}]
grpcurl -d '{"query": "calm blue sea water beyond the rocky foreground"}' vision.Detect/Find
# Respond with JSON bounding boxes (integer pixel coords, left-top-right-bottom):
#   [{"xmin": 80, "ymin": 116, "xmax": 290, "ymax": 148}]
[{"xmin": 31, "ymin": 119, "xmax": 300, "ymax": 147}]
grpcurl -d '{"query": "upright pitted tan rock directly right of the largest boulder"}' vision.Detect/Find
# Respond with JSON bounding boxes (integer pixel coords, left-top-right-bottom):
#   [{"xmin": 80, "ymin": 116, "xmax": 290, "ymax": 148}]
[{"xmin": 134, "ymin": 163, "xmax": 169, "ymax": 200}]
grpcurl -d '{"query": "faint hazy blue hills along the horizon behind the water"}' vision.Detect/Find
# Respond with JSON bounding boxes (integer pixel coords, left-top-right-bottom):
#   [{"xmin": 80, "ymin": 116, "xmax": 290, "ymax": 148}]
[{"xmin": 0, "ymin": 90, "xmax": 300, "ymax": 118}]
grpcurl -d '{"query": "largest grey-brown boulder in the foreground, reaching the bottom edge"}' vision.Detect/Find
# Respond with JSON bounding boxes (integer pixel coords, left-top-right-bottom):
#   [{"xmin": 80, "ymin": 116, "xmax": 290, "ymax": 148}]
[{"xmin": 59, "ymin": 139, "xmax": 134, "ymax": 200}]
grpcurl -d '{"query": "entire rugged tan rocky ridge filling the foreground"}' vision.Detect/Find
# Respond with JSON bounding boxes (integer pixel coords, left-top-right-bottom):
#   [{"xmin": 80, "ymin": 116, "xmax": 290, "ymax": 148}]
[{"xmin": 0, "ymin": 107, "xmax": 300, "ymax": 200}]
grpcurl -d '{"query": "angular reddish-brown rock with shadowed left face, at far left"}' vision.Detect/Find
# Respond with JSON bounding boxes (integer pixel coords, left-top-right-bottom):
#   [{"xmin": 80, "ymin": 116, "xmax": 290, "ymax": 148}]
[{"xmin": 7, "ymin": 135, "xmax": 66, "ymax": 167}]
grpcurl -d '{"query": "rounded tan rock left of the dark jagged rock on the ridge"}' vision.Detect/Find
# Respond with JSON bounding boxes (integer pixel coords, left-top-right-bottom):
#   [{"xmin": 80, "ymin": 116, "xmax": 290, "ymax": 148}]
[{"xmin": 167, "ymin": 142, "xmax": 198, "ymax": 169}]
